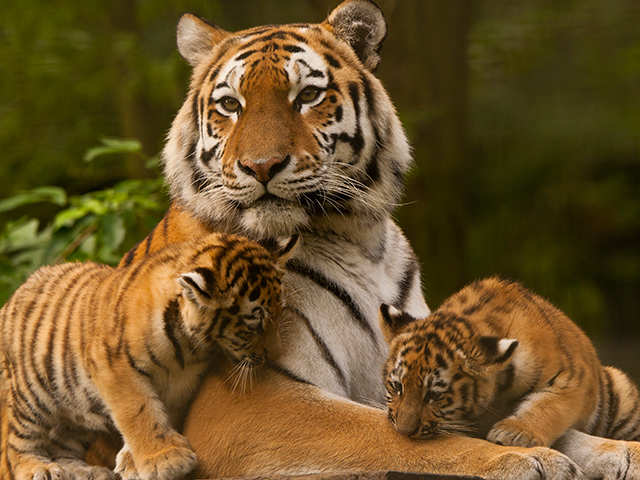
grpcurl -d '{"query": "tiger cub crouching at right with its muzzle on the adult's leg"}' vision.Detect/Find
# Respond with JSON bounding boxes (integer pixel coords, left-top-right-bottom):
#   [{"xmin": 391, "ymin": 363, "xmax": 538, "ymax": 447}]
[{"xmin": 380, "ymin": 278, "xmax": 640, "ymax": 447}]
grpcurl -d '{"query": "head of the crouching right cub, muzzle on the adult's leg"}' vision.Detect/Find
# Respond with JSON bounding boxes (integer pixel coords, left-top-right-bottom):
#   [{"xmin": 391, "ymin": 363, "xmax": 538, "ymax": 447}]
[{"xmin": 380, "ymin": 305, "xmax": 518, "ymax": 438}]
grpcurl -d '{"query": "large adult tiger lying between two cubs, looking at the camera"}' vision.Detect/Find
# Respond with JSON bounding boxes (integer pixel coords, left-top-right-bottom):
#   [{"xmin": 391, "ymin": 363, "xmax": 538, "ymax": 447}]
[{"xmin": 99, "ymin": 0, "xmax": 640, "ymax": 479}]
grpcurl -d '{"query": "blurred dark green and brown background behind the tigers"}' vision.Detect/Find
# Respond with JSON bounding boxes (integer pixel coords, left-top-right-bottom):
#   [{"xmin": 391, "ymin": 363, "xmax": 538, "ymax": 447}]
[{"xmin": 0, "ymin": 0, "xmax": 640, "ymax": 378}]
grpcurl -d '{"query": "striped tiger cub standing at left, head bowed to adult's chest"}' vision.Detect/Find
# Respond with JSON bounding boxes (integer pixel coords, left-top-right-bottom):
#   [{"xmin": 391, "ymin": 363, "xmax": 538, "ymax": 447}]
[{"xmin": 0, "ymin": 234, "xmax": 297, "ymax": 480}]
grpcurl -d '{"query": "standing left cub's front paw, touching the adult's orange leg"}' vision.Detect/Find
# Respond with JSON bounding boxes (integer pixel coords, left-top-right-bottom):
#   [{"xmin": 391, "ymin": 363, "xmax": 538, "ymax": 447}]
[{"xmin": 138, "ymin": 433, "xmax": 198, "ymax": 480}]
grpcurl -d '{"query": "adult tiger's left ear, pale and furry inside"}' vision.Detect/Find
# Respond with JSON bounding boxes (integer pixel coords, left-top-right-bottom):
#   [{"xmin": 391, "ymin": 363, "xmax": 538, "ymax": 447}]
[{"xmin": 176, "ymin": 13, "xmax": 230, "ymax": 67}]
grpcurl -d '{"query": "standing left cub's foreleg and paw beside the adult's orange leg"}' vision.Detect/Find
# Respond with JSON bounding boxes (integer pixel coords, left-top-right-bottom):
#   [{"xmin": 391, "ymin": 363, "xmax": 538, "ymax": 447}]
[{"xmin": 96, "ymin": 359, "xmax": 197, "ymax": 480}]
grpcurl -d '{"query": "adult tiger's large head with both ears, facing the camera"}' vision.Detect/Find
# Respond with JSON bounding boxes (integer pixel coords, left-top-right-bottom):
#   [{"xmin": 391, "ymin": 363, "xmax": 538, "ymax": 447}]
[{"xmin": 163, "ymin": 0, "xmax": 411, "ymax": 238}]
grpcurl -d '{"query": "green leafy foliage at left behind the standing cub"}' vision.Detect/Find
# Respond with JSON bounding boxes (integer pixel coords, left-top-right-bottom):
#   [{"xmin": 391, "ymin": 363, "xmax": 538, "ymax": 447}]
[{"xmin": 0, "ymin": 139, "xmax": 167, "ymax": 303}]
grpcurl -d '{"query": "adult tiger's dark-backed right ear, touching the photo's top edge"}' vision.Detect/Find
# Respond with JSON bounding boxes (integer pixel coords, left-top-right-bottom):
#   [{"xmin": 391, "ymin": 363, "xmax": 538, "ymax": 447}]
[{"xmin": 325, "ymin": 0, "xmax": 387, "ymax": 70}]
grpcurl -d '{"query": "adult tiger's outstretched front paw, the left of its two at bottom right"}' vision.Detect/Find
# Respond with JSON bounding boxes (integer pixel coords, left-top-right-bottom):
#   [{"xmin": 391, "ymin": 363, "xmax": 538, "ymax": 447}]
[{"xmin": 482, "ymin": 447, "xmax": 586, "ymax": 480}]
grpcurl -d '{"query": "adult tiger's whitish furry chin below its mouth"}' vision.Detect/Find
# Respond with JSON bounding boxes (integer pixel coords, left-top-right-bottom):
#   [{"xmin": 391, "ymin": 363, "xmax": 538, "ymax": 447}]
[{"xmin": 240, "ymin": 199, "xmax": 310, "ymax": 239}]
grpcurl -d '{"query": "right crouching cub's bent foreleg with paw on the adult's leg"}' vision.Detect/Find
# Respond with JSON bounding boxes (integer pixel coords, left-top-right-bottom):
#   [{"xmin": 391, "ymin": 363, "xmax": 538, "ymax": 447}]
[{"xmin": 487, "ymin": 388, "xmax": 584, "ymax": 447}]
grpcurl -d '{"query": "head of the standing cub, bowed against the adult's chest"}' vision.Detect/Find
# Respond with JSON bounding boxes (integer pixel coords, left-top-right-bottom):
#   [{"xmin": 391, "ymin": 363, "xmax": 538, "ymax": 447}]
[{"xmin": 177, "ymin": 234, "xmax": 298, "ymax": 366}]
